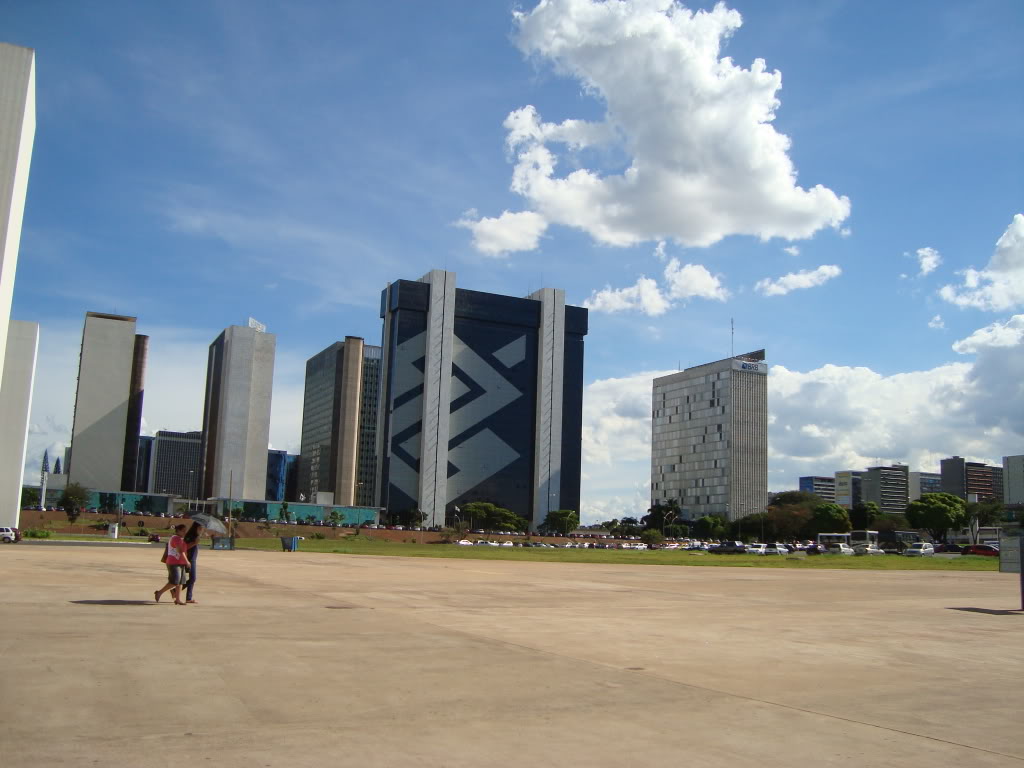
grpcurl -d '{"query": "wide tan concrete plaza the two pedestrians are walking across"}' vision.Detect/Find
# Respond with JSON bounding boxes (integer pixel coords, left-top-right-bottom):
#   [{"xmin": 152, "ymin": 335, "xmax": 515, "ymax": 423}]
[{"xmin": 0, "ymin": 543, "xmax": 1024, "ymax": 768}]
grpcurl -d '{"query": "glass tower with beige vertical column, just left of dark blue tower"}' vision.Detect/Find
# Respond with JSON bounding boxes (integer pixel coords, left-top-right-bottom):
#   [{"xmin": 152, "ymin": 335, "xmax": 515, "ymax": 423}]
[{"xmin": 299, "ymin": 336, "xmax": 381, "ymax": 506}]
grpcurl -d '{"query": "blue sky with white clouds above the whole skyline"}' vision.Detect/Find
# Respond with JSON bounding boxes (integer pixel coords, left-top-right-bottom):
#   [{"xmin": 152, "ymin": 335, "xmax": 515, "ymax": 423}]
[{"xmin": 0, "ymin": 0, "xmax": 1024, "ymax": 519}]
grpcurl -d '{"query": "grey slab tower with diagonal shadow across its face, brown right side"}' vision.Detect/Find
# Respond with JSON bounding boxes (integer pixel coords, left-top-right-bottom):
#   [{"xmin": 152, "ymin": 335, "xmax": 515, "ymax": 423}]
[{"xmin": 65, "ymin": 312, "xmax": 150, "ymax": 490}]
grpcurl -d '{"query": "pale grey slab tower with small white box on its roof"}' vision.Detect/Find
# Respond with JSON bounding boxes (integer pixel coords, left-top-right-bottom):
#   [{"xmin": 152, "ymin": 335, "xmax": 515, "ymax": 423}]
[{"xmin": 200, "ymin": 322, "xmax": 276, "ymax": 500}]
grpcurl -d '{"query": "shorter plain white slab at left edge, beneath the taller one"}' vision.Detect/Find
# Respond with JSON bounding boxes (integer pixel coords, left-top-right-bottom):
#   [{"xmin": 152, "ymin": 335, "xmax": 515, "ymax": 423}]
[{"xmin": 0, "ymin": 321, "xmax": 39, "ymax": 527}]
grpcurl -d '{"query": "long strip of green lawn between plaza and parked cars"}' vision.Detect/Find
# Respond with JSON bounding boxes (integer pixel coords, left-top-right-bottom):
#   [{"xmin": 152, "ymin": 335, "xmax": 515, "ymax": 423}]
[{"xmin": 236, "ymin": 536, "xmax": 999, "ymax": 570}]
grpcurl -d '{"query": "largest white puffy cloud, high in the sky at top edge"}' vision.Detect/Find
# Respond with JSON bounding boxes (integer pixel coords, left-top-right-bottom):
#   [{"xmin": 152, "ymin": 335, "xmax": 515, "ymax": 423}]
[{"xmin": 460, "ymin": 0, "xmax": 850, "ymax": 259}]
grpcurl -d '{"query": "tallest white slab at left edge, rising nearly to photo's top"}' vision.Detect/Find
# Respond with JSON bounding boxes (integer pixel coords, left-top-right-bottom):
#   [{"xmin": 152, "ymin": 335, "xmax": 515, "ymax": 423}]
[{"xmin": 0, "ymin": 43, "xmax": 36, "ymax": 382}]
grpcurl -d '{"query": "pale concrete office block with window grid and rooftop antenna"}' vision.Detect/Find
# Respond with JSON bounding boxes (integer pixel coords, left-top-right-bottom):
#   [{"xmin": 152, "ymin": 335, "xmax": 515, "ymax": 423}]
[{"xmin": 650, "ymin": 349, "xmax": 768, "ymax": 520}]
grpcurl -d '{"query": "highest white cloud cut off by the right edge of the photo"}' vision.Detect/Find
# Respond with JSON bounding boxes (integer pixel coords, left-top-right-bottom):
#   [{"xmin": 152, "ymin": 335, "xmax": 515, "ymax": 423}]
[{"xmin": 939, "ymin": 213, "xmax": 1024, "ymax": 312}]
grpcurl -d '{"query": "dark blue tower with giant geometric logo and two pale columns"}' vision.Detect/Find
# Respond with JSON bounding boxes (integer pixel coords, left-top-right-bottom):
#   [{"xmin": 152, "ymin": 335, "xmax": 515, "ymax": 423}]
[{"xmin": 378, "ymin": 269, "xmax": 588, "ymax": 529}]
